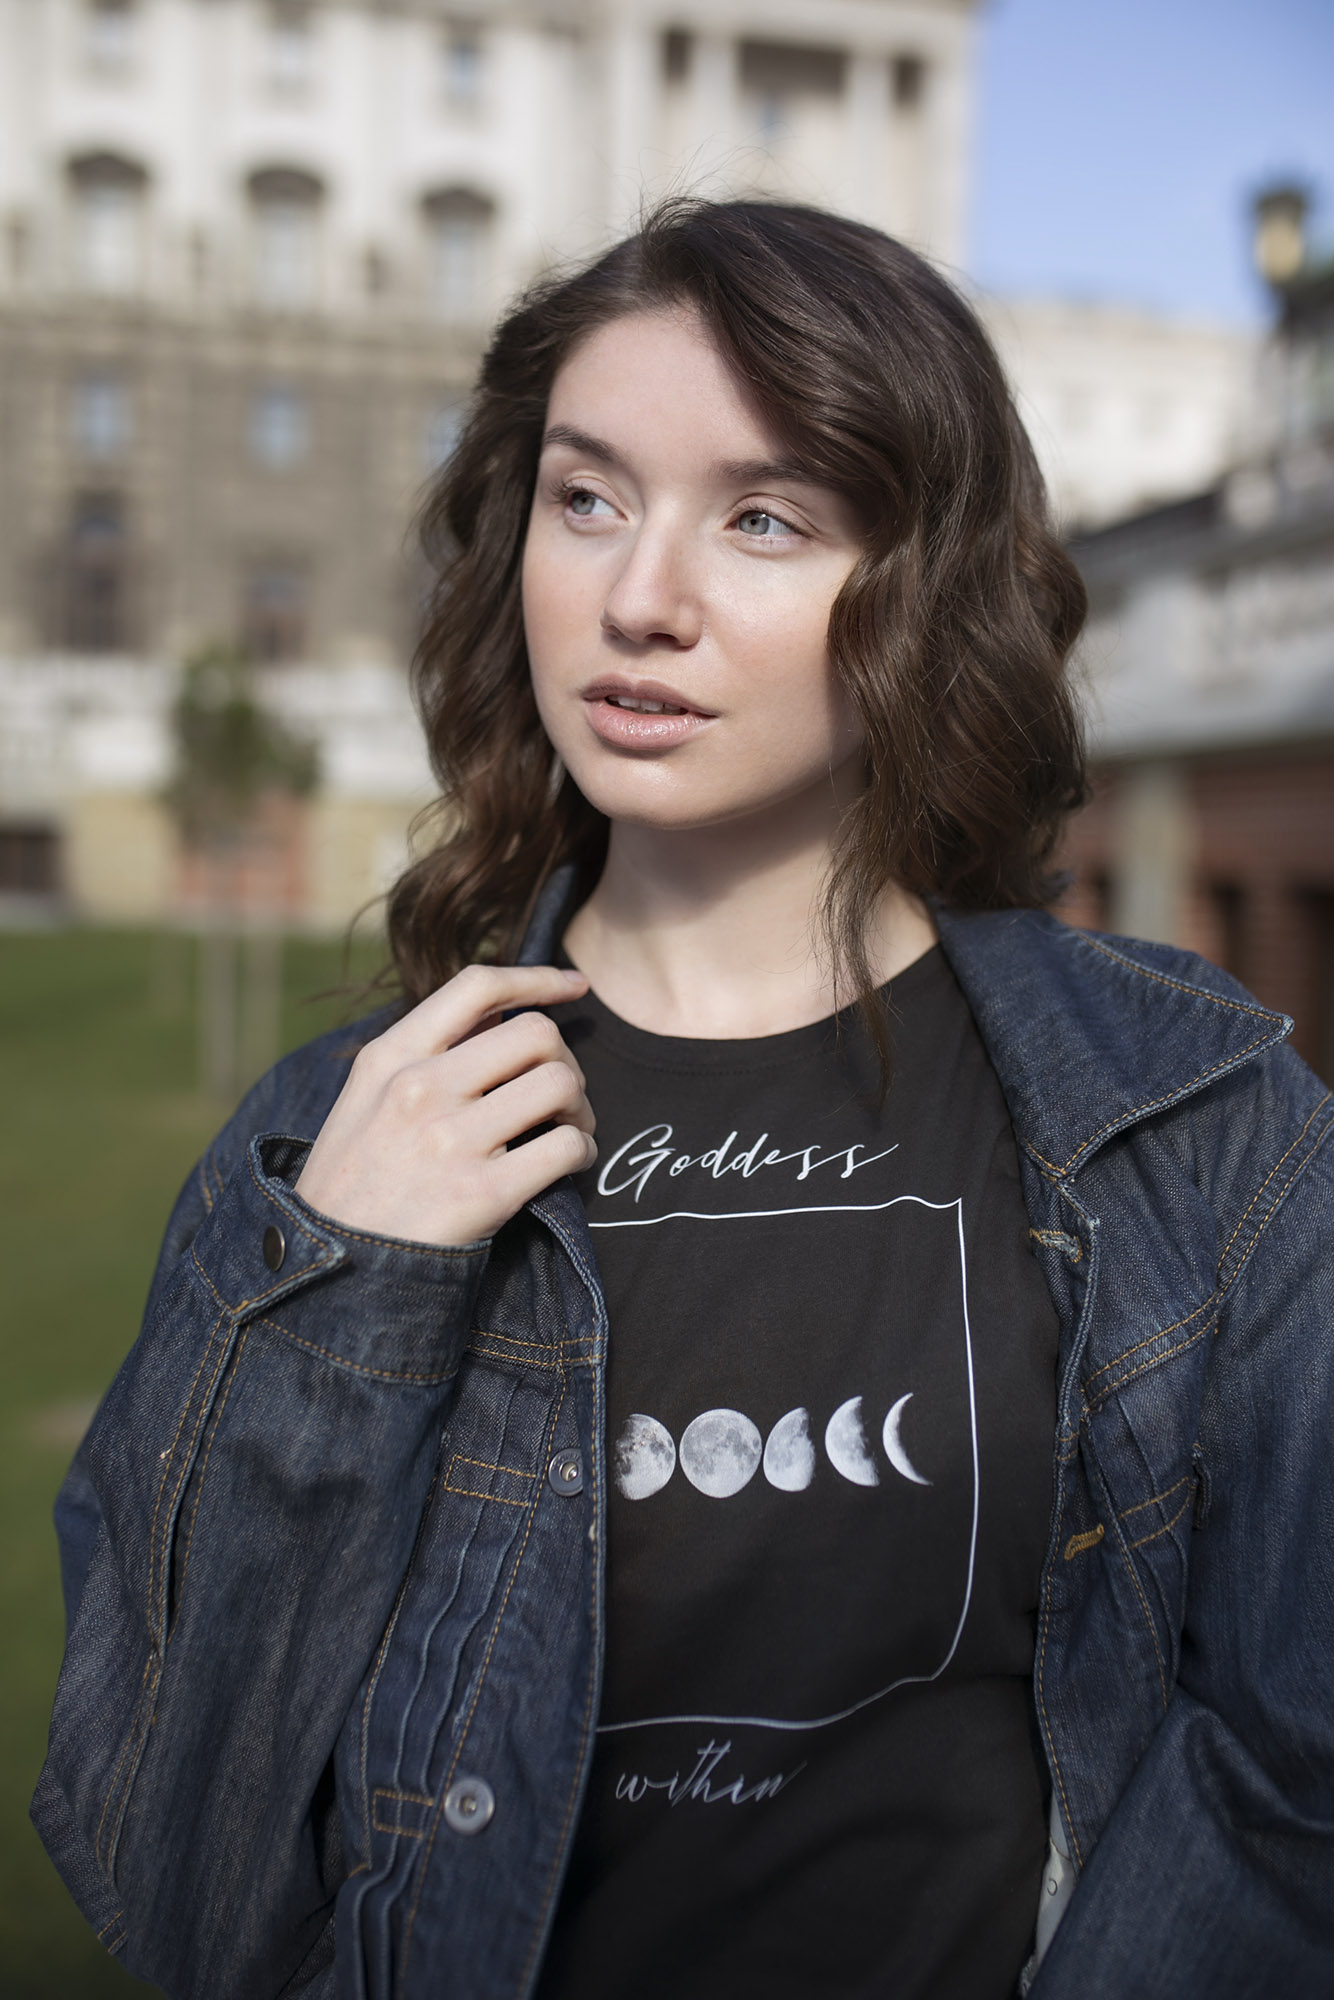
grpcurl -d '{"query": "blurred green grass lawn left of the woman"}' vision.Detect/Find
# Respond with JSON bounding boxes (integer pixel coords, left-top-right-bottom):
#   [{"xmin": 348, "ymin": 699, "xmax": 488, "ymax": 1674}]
[{"xmin": 0, "ymin": 930, "xmax": 382, "ymax": 2000}]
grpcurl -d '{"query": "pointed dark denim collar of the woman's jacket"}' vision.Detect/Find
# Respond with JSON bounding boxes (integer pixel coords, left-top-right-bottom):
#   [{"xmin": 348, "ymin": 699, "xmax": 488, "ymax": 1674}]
[{"xmin": 518, "ymin": 866, "xmax": 1292, "ymax": 1180}]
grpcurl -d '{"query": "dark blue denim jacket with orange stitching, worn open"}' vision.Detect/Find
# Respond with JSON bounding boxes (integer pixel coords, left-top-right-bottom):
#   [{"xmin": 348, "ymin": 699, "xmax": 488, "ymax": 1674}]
[{"xmin": 34, "ymin": 882, "xmax": 1334, "ymax": 2000}]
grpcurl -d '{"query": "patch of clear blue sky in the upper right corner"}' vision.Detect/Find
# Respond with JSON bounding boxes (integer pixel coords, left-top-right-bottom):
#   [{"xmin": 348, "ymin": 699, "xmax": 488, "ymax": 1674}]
[{"xmin": 968, "ymin": 0, "xmax": 1334, "ymax": 322}]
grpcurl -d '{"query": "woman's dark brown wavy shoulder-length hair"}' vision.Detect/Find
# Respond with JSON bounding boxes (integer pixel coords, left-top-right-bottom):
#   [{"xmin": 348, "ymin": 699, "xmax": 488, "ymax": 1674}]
[{"xmin": 388, "ymin": 200, "xmax": 1086, "ymax": 1016}]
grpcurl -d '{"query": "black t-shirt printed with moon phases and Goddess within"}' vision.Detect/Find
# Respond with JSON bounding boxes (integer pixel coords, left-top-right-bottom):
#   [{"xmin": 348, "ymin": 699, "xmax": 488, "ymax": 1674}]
[{"xmin": 540, "ymin": 948, "xmax": 1056, "ymax": 2000}]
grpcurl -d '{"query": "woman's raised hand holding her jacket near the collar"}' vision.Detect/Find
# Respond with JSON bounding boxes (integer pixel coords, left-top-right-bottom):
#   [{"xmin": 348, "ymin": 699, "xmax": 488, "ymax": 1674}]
[{"xmin": 296, "ymin": 966, "xmax": 598, "ymax": 1244}]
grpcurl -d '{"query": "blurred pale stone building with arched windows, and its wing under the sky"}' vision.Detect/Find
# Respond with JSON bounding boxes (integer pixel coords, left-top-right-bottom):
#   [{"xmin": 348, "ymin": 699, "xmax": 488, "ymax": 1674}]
[{"xmin": 0, "ymin": 0, "xmax": 1248, "ymax": 926}]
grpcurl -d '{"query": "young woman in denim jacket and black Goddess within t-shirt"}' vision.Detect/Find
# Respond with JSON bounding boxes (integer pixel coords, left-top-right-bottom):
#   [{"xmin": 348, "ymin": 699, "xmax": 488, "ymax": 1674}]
[{"xmin": 36, "ymin": 204, "xmax": 1334, "ymax": 2000}]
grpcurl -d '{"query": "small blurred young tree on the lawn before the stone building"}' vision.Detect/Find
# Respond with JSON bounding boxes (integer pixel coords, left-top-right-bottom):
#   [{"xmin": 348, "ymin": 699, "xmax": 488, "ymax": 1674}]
[{"xmin": 164, "ymin": 646, "xmax": 320, "ymax": 1102}]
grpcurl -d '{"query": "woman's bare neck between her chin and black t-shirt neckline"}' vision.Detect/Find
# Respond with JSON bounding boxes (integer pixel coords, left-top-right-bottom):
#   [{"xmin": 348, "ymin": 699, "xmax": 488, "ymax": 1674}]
[{"xmin": 564, "ymin": 814, "xmax": 936, "ymax": 1040}]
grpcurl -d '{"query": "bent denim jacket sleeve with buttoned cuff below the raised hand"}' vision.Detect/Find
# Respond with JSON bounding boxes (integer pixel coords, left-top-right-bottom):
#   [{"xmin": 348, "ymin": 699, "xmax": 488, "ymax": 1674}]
[{"xmin": 32, "ymin": 1078, "xmax": 486, "ymax": 2000}]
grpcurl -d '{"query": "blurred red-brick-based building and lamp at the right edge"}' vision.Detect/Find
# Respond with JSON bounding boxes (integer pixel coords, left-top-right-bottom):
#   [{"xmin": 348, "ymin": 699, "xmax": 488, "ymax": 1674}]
[{"xmin": 1066, "ymin": 190, "xmax": 1334, "ymax": 1080}]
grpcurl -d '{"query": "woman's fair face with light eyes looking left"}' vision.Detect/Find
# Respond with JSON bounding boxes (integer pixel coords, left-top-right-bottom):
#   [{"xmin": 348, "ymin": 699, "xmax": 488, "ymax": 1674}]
[{"xmin": 524, "ymin": 310, "xmax": 862, "ymax": 828}]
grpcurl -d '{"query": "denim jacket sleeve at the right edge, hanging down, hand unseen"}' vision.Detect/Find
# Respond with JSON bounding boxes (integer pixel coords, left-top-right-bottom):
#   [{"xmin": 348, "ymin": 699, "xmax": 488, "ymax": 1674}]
[{"xmin": 1032, "ymin": 1078, "xmax": 1334, "ymax": 2000}]
